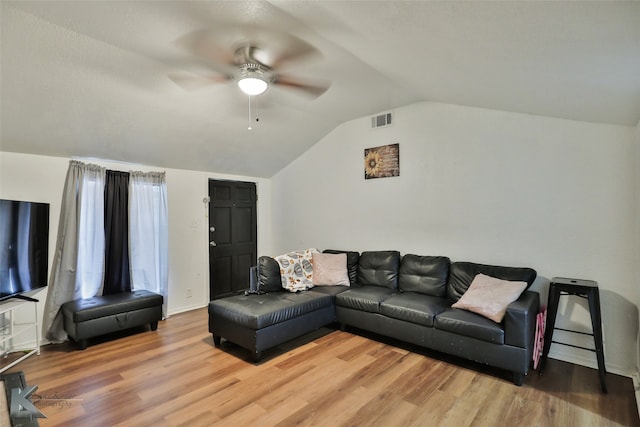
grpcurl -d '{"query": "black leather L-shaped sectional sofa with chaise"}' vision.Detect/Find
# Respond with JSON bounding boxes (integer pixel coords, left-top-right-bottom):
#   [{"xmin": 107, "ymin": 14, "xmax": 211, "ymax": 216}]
[{"xmin": 209, "ymin": 250, "xmax": 539, "ymax": 385}]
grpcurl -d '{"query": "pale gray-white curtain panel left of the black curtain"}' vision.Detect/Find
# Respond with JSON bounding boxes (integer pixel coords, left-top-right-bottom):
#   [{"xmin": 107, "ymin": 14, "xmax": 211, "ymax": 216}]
[{"xmin": 42, "ymin": 160, "xmax": 105, "ymax": 342}]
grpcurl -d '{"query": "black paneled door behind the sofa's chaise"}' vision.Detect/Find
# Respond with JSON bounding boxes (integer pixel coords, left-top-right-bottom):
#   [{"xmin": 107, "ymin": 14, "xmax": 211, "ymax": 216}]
[{"xmin": 209, "ymin": 180, "xmax": 258, "ymax": 299}]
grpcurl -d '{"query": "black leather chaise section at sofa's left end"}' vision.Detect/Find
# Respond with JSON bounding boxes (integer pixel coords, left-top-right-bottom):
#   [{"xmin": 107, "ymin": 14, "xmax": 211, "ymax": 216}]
[{"xmin": 209, "ymin": 291, "xmax": 335, "ymax": 362}]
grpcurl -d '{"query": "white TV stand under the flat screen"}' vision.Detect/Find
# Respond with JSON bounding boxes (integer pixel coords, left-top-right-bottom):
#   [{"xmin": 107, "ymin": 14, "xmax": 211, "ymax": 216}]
[{"xmin": 0, "ymin": 295, "xmax": 40, "ymax": 373}]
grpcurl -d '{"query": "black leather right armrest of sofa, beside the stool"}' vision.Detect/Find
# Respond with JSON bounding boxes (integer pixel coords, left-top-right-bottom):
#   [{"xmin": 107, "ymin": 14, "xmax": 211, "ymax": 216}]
[{"xmin": 504, "ymin": 291, "xmax": 540, "ymax": 351}]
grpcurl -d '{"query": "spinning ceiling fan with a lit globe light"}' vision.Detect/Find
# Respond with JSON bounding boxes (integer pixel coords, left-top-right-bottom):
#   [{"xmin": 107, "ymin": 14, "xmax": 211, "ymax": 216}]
[{"xmin": 169, "ymin": 26, "xmax": 331, "ymax": 98}]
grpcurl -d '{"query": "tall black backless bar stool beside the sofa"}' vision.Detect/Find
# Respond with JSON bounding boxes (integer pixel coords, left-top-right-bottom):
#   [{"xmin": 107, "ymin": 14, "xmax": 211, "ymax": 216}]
[{"xmin": 539, "ymin": 277, "xmax": 607, "ymax": 393}]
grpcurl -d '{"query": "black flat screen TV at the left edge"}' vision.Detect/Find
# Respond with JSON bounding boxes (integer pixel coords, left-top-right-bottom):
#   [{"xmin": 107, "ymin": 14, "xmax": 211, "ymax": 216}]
[{"xmin": 0, "ymin": 199, "xmax": 49, "ymax": 300}]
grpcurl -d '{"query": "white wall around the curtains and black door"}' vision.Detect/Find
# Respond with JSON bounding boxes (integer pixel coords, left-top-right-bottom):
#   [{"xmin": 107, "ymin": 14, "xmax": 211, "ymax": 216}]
[{"xmin": 0, "ymin": 152, "xmax": 271, "ymax": 344}]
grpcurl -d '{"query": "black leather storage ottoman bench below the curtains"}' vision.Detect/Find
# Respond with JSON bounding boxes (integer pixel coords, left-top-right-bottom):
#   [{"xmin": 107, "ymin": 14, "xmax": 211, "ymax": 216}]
[{"xmin": 61, "ymin": 290, "xmax": 162, "ymax": 350}]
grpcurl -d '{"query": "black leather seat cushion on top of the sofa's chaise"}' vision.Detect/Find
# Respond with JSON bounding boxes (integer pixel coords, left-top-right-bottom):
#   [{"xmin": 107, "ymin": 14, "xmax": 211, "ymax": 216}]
[{"xmin": 209, "ymin": 290, "xmax": 333, "ymax": 330}]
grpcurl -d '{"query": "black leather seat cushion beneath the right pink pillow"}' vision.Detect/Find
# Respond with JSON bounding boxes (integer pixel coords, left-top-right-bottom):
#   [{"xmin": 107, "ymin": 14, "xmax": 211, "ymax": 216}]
[{"xmin": 434, "ymin": 308, "xmax": 504, "ymax": 344}]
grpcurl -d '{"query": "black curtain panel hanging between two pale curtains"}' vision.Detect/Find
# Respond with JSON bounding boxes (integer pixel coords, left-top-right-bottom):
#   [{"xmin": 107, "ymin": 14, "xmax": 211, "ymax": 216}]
[{"xmin": 102, "ymin": 170, "xmax": 131, "ymax": 295}]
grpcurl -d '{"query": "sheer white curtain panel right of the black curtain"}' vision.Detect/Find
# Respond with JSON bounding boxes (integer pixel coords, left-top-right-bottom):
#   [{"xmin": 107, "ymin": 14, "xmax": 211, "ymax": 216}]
[{"xmin": 129, "ymin": 172, "xmax": 169, "ymax": 318}]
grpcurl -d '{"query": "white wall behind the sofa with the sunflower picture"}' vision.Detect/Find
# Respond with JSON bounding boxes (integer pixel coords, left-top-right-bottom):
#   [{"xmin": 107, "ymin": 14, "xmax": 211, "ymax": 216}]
[{"xmin": 272, "ymin": 103, "xmax": 638, "ymax": 374}]
